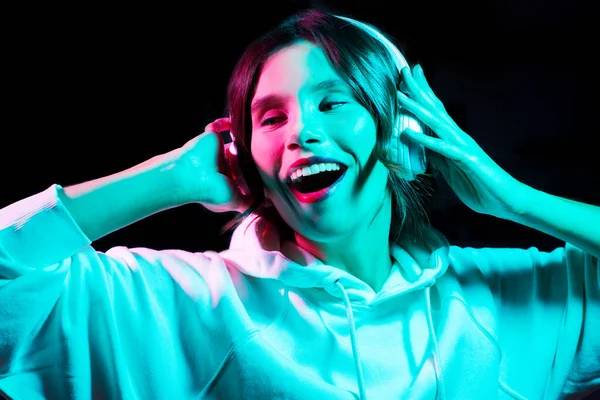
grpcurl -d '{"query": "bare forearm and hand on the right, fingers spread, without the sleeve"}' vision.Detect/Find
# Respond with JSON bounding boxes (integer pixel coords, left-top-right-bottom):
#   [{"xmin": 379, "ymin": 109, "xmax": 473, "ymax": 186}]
[{"xmin": 398, "ymin": 66, "xmax": 600, "ymax": 257}]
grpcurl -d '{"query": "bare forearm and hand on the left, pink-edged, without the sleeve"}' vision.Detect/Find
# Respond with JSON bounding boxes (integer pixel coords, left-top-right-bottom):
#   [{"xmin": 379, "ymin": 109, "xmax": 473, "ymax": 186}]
[{"xmin": 59, "ymin": 122, "xmax": 254, "ymax": 241}]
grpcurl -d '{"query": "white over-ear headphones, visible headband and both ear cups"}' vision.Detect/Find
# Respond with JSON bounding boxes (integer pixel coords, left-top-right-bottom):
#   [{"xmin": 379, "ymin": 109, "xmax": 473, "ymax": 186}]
[{"xmin": 225, "ymin": 15, "xmax": 428, "ymax": 195}]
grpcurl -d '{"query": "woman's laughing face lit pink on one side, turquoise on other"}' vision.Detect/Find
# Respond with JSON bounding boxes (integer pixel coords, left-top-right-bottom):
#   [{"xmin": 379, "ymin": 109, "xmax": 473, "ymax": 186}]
[{"xmin": 251, "ymin": 41, "xmax": 389, "ymax": 242}]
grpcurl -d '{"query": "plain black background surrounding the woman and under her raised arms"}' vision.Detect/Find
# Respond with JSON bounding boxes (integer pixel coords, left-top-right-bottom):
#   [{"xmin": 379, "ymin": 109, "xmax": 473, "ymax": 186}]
[{"xmin": 0, "ymin": 0, "xmax": 600, "ymax": 251}]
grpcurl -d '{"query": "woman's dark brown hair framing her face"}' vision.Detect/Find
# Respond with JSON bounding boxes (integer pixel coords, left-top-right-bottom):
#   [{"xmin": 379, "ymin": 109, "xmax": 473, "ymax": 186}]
[{"xmin": 221, "ymin": 9, "xmax": 433, "ymax": 241}]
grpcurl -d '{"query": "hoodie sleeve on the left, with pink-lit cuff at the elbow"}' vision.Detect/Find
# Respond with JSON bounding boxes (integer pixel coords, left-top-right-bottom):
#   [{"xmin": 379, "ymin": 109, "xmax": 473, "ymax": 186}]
[{"xmin": 0, "ymin": 185, "xmax": 230, "ymax": 399}]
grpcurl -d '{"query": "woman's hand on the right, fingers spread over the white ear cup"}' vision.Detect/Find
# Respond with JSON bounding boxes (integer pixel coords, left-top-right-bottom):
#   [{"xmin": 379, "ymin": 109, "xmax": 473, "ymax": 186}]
[{"xmin": 398, "ymin": 65, "xmax": 525, "ymax": 219}]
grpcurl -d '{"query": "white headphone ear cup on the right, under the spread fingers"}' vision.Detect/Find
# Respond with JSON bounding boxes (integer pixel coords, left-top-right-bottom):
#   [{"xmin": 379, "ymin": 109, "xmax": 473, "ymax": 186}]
[{"xmin": 388, "ymin": 110, "xmax": 427, "ymax": 181}]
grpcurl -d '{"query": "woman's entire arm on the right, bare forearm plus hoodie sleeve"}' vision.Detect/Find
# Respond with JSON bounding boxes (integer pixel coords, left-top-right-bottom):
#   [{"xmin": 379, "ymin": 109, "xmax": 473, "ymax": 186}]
[{"xmin": 398, "ymin": 67, "xmax": 600, "ymax": 398}]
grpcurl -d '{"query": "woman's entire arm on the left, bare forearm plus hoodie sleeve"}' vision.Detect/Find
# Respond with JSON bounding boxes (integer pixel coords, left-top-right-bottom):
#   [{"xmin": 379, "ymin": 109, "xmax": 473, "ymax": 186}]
[{"xmin": 0, "ymin": 122, "xmax": 248, "ymax": 398}]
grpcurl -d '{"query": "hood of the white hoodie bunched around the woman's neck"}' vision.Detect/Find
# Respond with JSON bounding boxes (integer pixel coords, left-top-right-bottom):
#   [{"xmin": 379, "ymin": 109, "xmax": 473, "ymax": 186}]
[{"xmin": 222, "ymin": 214, "xmax": 449, "ymax": 304}]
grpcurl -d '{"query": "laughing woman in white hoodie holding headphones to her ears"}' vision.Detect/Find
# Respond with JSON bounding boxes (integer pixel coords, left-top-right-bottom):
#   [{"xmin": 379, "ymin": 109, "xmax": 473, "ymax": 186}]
[{"xmin": 0, "ymin": 10, "xmax": 600, "ymax": 399}]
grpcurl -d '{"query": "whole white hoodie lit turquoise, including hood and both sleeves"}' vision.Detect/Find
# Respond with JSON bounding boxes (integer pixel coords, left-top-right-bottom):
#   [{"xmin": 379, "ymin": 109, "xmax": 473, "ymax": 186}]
[{"xmin": 0, "ymin": 185, "xmax": 600, "ymax": 400}]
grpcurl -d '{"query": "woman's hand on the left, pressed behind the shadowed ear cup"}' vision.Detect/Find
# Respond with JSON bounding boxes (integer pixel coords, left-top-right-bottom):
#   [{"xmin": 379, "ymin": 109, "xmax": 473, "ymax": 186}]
[{"xmin": 176, "ymin": 118, "xmax": 254, "ymax": 213}]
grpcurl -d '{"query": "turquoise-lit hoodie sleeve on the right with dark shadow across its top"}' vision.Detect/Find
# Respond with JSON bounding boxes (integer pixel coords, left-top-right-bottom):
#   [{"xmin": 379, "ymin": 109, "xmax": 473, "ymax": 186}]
[{"xmin": 455, "ymin": 243, "xmax": 600, "ymax": 399}]
